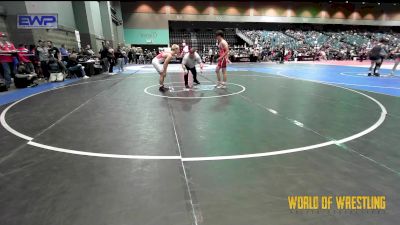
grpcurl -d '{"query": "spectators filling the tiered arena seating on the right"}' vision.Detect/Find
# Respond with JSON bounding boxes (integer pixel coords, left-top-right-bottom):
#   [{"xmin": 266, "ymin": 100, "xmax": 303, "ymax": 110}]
[{"xmin": 242, "ymin": 29, "xmax": 400, "ymax": 61}]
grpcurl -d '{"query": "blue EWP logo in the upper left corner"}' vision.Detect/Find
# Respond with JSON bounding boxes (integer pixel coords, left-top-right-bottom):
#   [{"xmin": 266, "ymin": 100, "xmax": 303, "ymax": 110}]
[{"xmin": 17, "ymin": 14, "xmax": 58, "ymax": 29}]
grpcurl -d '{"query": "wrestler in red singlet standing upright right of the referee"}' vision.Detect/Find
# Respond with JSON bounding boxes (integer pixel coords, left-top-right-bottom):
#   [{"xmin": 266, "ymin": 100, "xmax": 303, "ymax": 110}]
[{"xmin": 215, "ymin": 30, "xmax": 229, "ymax": 88}]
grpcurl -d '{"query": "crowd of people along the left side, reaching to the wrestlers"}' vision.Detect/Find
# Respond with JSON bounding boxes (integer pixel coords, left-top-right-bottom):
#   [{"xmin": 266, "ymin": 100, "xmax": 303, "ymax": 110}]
[{"xmin": 0, "ymin": 32, "xmax": 164, "ymax": 91}]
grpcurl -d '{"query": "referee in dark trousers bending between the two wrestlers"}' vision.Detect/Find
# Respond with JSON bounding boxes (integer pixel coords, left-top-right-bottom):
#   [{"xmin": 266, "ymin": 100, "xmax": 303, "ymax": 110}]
[{"xmin": 182, "ymin": 48, "xmax": 203, "ymax": 88}]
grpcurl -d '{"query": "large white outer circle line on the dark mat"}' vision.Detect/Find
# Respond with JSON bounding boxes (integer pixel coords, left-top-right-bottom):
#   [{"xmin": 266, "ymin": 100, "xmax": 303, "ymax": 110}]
[{"xmin": 0, "ymin": 71, "xmax": 387, "ymax": 162}]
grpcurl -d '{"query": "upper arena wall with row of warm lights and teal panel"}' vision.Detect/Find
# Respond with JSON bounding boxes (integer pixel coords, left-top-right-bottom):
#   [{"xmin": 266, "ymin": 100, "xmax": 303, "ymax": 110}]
[{"xmin": 121, "ymin": 1, "xmax": 400, "ymax": 44}]
